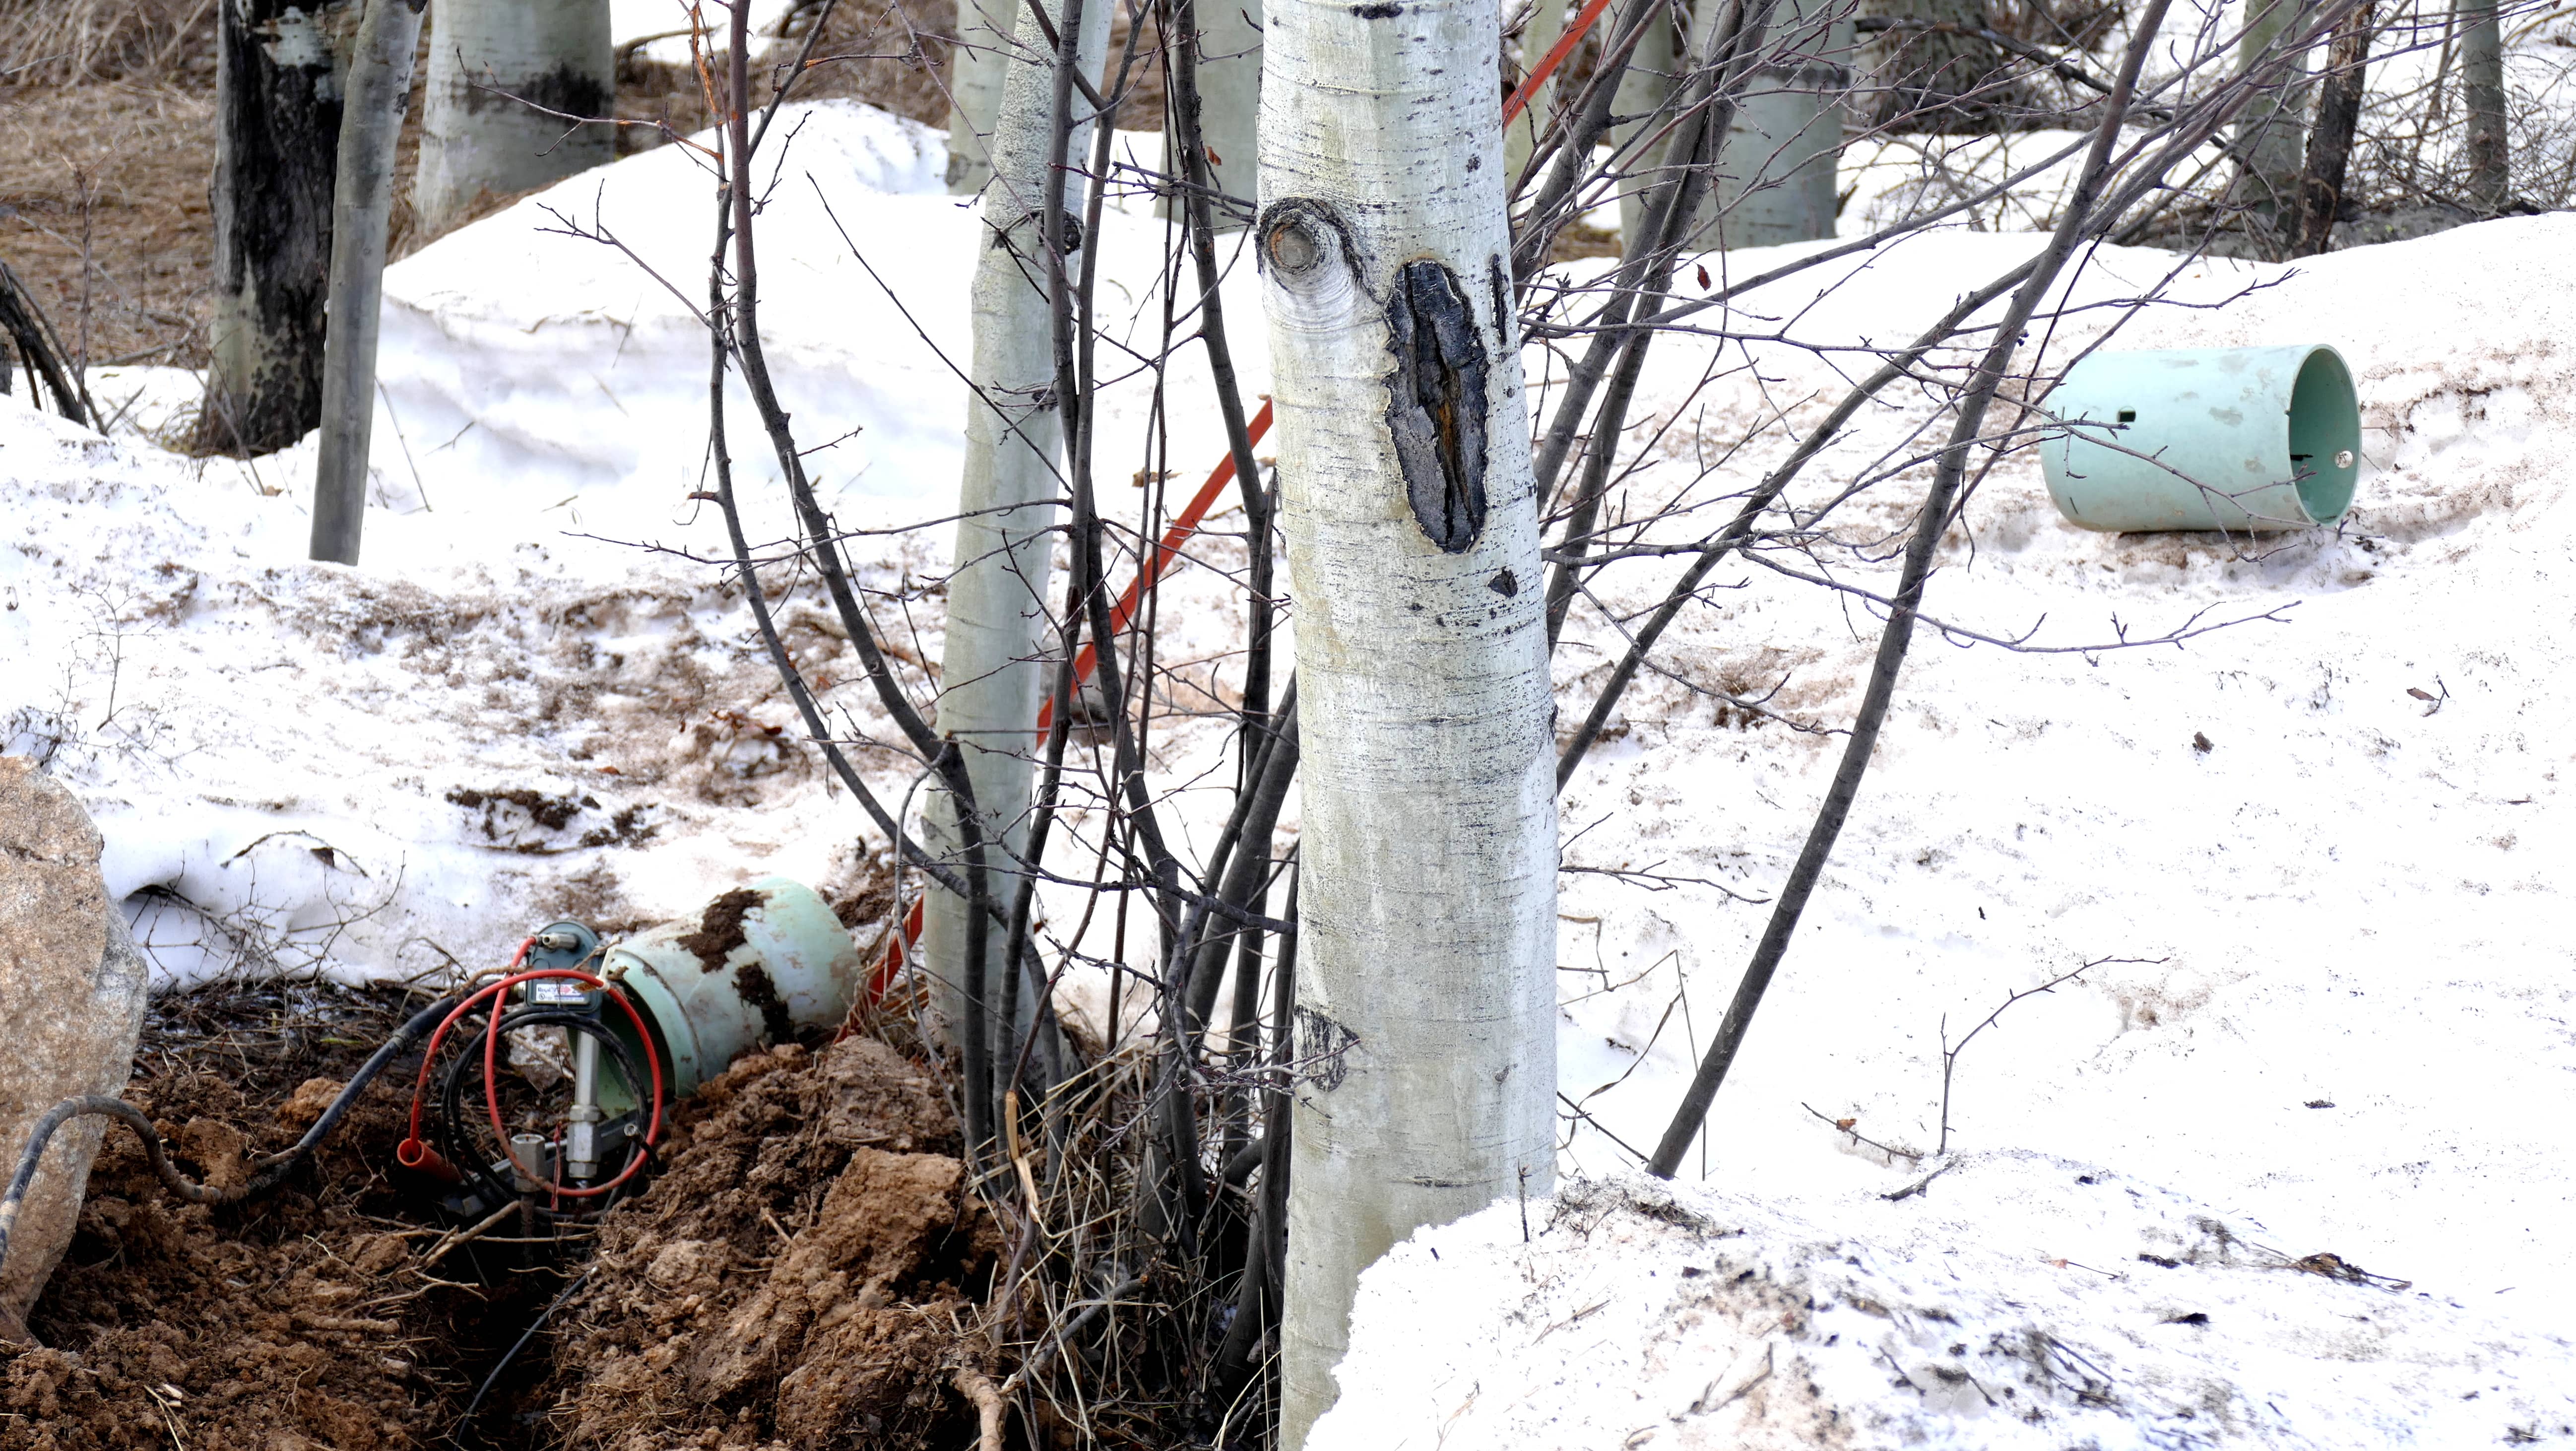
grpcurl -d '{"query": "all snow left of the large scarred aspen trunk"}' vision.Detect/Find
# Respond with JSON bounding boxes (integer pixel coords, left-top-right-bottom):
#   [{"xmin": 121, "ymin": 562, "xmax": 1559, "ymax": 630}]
[{"xmin": 0, "ymin": 101, "xmax": 1267, "ymax": 980}]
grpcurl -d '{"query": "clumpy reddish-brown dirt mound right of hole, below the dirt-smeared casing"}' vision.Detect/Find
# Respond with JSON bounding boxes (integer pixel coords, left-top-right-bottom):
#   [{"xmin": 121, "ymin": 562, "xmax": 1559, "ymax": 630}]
[{"xmin": 536, "ymin": 1039, "xmax": 997, "ymax": 1451}]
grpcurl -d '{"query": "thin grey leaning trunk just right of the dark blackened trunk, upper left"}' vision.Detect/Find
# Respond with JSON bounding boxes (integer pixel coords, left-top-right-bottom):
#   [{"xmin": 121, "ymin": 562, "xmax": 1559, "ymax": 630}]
[{"xmin": 312, "ymin": 0, "xmax": 428, "ymax": 564}]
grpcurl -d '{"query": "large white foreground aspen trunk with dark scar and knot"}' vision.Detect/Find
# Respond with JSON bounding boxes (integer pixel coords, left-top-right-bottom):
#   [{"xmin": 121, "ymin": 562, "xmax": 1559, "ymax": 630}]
[{"xmin": 1257, "ymin": 0, "xmax": 1556, "ymax": 1451}]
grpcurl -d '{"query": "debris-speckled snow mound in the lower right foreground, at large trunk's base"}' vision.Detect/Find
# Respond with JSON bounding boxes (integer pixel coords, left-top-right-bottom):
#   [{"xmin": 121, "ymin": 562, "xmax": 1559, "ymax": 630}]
[{"xmin": 1309, "ymin": 1152, "xmax": 2576, "ymax": 1451}]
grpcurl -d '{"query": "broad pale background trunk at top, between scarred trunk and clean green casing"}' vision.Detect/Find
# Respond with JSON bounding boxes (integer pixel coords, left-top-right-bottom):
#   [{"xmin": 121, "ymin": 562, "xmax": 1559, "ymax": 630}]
[{"xmin": 1700, "ymin": 0, "xmax": 1857, "ymax": 248}]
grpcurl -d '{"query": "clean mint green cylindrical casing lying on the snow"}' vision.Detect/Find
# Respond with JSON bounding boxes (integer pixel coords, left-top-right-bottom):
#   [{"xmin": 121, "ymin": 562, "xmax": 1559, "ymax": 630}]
[{"xmin": 2040, "ymin": 343, "xmax": 2362, "ymax": 533}]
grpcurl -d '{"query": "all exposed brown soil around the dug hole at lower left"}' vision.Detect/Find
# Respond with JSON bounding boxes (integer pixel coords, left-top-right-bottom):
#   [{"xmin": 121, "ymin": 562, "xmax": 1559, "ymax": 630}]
[{"xmin": 0, "ymin": 987, "xmax": 997, "ymax": 1451}]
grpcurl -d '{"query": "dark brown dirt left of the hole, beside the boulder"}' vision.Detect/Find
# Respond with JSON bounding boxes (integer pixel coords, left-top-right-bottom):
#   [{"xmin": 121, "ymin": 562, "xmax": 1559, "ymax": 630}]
[{"xmin": 0, "ymin": 989, "xmax": 530, "ymax": 1451}]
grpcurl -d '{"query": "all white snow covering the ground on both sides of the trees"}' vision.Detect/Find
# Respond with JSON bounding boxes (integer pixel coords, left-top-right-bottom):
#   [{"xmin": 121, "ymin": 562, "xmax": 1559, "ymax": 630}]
[{"xmin": 0, "ymin": 103, "xmax": 2576, "ymax": 1446}]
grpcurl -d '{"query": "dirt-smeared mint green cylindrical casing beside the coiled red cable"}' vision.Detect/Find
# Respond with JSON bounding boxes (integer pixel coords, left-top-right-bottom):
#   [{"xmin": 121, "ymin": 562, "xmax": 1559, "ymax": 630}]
[{"xmin": 600, "ymin": 876, "xmax": 866, "ymax": 1098}]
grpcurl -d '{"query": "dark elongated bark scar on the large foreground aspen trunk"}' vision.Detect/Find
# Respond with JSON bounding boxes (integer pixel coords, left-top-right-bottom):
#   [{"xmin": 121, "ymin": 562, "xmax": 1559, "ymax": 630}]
[{"xmin": 1386, "ymin": 258, "xmax": 1486, "ymax": 554}]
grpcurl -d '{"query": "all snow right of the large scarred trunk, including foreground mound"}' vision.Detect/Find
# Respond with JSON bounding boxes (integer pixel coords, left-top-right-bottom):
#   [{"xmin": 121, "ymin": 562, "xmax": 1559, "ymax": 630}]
[{"xmin": 1453, "ymin": 216, "xmax": 2576, "ymax": 1451}]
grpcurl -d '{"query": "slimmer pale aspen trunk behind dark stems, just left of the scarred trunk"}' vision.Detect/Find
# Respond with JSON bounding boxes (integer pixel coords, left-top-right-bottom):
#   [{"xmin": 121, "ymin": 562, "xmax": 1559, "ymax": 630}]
[{"xmin": 922, "ymin": 0, "xmax": 1110, "ymax": 1056}]
